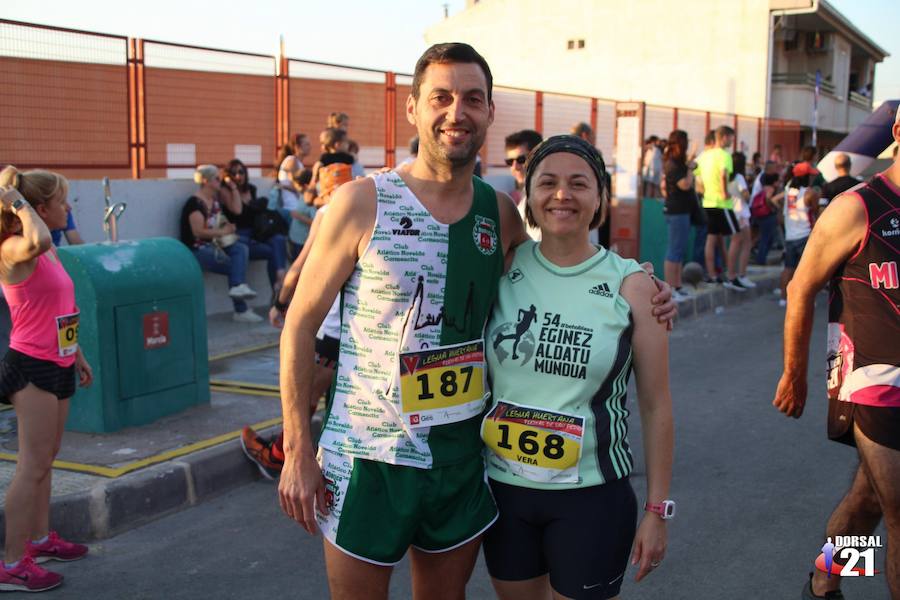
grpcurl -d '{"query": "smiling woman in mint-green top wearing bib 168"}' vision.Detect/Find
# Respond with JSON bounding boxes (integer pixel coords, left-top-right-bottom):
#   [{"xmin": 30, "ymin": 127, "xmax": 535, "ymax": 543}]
[{"xmin": 482, "ymin": 136, "xmax": 674, "ymax": 600}]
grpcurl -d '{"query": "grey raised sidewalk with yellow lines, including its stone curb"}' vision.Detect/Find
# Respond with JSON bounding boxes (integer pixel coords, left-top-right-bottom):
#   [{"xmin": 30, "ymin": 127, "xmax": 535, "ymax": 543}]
[{"xmin": 0, "ymin": 266, "xmax": 781, "ymax": 541}]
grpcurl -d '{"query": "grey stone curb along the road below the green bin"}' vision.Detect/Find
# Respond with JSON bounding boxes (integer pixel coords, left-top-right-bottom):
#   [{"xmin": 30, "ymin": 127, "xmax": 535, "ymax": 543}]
[{"xmin": 0, "ymin": 415, "xmax": 322, "ymax": 542}]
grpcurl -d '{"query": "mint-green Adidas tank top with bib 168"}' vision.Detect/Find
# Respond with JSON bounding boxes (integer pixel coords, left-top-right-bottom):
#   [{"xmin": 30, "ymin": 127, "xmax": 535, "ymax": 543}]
[{"xmin": 482, "ymin": 242, "xmax": 640, "ymax": 489}]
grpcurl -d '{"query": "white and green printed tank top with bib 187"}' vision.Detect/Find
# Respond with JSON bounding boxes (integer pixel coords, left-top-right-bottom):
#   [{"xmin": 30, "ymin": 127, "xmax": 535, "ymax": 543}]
[{"xmin": 319, "ymin": 172, "xmax": 503, "ymax": 468}]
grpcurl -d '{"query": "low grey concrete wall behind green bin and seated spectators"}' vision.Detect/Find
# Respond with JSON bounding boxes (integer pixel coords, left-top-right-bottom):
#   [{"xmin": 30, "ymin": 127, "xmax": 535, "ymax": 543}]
[{"xmin": 63, "ymin": 179, "xmax": 272, "ymax": 314}]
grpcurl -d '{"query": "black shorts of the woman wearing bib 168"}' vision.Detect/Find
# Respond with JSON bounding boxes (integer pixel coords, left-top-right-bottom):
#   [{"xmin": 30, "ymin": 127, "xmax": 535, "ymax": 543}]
[{"xmin": 484, "ymin": 477, "xmax": 637, "ymax": 599}]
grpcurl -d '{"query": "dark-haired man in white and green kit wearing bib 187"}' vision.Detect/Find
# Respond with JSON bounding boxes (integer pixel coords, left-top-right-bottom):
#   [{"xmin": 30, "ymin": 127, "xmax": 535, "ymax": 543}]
[{"xmin": 279, "ymin": 43, "xmax": 671, "ymax": 599}]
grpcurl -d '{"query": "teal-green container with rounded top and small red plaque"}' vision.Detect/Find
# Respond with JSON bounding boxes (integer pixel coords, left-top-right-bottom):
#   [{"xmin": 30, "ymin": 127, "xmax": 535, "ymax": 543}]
[{"xmin": 59, "ymin": 238, "xmax": 209, "ymax": 433}]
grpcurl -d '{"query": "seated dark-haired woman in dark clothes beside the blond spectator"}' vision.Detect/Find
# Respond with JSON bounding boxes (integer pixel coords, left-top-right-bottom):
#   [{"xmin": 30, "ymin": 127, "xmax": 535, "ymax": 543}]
[{"xmin": 222, "ymin": 158, "xmax": 287, "ymax": 289}]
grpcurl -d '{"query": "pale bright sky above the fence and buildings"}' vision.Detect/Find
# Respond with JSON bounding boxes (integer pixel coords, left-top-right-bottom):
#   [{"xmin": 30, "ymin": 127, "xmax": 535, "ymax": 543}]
[{"xmin": 0, "ymin": 0, "xmax": 900, "ymax": 106}]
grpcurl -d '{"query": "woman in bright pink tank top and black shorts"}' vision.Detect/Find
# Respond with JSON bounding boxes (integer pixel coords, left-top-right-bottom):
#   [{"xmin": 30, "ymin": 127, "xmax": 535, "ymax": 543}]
[{"xmin": 0, "ymin": 167, "xmax": 93, "ymax": 592}]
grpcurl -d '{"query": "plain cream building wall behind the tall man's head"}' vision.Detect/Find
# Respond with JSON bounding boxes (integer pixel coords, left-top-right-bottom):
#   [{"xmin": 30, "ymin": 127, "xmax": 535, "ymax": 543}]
[{"xmin": 425, "ymin": 0, "xmax": 769, "ymax": 116}]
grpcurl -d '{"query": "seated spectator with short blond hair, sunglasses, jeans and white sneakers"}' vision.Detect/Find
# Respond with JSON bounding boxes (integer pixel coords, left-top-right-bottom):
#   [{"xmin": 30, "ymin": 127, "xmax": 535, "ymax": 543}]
[{"xmin": 180, "ymin": 165, "xmax": 263, "ymax": 323}]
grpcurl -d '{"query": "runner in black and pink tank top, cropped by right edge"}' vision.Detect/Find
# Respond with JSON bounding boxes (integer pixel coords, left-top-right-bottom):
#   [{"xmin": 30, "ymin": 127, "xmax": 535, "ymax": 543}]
[{"xmin": 773, "ymin": 111, "xmax": 900, "ymax": 600}]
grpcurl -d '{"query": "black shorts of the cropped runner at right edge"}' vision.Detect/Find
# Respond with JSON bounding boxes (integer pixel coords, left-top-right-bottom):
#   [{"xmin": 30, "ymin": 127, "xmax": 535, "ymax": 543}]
[{"xmin": 828, "ymin": 398, "xmax": 900, "ymax": 450}]
